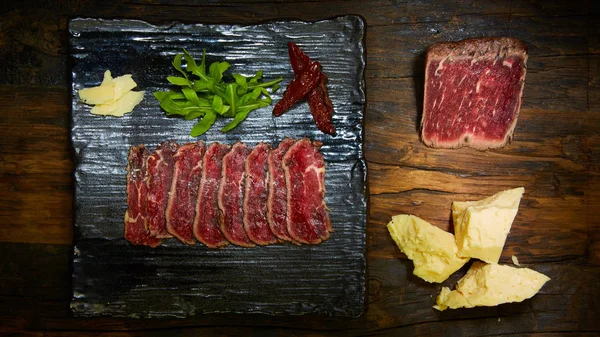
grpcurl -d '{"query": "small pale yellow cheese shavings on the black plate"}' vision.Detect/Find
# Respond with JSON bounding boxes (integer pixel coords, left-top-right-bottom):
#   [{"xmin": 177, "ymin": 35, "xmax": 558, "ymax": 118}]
[{"xmin": 78, "ymin": 70, "xmax": 144, "ymax": 117}]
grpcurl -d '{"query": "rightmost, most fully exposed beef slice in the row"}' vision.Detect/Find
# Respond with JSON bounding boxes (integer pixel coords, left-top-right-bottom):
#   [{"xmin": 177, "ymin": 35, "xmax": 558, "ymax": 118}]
[{"xmin": 282, "ymin": 138, "xmax": 333, "ymax": 244}]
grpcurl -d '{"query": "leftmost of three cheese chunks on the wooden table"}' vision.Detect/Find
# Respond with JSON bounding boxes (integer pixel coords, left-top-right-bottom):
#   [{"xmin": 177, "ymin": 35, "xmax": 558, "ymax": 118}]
[{"xmin": 387, "ymin": 214, "xmax": 469, "ymax": 282}]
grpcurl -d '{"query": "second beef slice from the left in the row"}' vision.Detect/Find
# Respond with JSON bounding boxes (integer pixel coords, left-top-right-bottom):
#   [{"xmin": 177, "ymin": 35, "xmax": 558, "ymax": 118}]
[{"xmin": 146, "ymin": 140, "xmax": 177, "ymax": 238}]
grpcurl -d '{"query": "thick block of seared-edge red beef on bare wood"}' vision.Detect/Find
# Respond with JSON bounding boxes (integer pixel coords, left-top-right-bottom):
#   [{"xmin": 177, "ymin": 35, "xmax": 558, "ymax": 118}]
[{"xmin": 421, "ymin": 37, "xmax": 527, "ymax": 150}]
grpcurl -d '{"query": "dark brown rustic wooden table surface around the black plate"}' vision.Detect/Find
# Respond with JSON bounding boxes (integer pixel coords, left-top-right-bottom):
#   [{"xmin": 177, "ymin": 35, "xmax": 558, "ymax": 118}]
[{"xmin": 0, "ymin": 0, "xmax": 600, "ymax": 336}]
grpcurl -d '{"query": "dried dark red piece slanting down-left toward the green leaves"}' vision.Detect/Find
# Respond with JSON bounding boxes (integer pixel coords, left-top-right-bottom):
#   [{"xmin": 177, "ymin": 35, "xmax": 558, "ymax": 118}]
[{"xmin": 273, "ymin": 62, "xmax": 321, "ymax": 116}]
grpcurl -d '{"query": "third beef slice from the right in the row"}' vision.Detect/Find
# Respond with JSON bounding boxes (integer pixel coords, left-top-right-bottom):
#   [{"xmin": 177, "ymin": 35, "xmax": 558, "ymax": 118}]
[{"xmin": 243, "ymin": 143, "xmax": 278, "ymax": 246}]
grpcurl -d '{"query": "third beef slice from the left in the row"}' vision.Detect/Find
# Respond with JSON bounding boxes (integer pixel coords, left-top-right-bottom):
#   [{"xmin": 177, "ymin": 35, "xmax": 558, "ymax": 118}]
[{"xmin": 167, "ymin": 141, "xmax": 206, "ymax": 245}]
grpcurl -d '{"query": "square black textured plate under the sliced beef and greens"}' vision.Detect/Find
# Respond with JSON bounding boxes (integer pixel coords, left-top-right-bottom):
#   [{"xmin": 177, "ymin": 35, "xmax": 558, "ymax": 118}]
[{"xmin": 69, "ymin": 16, "xmax": 367, "ymax": 317}]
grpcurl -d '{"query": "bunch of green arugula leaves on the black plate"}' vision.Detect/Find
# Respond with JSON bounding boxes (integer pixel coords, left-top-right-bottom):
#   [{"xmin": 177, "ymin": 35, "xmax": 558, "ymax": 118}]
[{"xmin": 154, "ymin": 49, "xmax": 283, "ymax": 137}]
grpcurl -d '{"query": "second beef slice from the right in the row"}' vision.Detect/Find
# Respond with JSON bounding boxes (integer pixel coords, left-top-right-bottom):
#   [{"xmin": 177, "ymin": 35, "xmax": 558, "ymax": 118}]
[{"xmin": 267, "ymin": 138, "xmax": 295, "ymax": 241}]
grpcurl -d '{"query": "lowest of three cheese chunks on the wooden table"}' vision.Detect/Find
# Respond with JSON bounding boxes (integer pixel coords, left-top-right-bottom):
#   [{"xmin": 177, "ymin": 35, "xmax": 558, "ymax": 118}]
[{"xmin": 434, "ymin": 261, "xmax": 550, "ymax": 311}]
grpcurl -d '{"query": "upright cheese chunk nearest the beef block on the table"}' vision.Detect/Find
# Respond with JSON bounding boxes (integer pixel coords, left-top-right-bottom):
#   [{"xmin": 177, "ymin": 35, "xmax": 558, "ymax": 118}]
[{"xmin": 452, "ymin": 187, "xmax": 525, "ymax": 263}]
